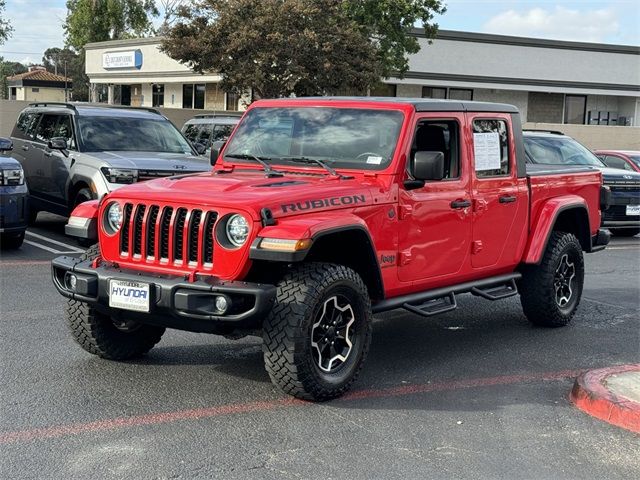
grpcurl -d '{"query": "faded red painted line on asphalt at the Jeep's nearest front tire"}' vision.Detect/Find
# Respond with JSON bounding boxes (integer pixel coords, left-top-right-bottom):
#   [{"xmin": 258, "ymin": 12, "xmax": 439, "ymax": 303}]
[{"xmin": 0, "ymin": 370, "xmax": 584, "ymax": 445}]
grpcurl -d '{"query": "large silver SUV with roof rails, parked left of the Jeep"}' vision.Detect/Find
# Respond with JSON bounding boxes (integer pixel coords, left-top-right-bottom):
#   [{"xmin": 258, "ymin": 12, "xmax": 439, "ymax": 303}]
[{"xmin": 11, "ymin": 103, "xmax": 211, "ymax": 222}]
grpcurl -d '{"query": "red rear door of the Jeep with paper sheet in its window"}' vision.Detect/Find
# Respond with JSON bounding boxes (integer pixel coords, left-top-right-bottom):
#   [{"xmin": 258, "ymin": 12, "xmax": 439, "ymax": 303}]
[{"xmin": 467, "ymin": 113, "xmax": 529, "ymax": 274}]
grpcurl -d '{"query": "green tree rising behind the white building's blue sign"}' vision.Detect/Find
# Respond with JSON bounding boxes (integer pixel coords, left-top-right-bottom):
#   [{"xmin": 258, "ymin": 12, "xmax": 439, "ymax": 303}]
[{"xmin": 64, "ymin": 0, "xmax": 158, "ymax": 51}]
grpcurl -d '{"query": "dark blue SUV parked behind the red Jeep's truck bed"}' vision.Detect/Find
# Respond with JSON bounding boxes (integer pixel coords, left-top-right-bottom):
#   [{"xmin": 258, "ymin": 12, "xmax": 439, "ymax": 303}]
[{"xmin": 524, "ymin": 131, "xmax": 640, "ymax": 237}]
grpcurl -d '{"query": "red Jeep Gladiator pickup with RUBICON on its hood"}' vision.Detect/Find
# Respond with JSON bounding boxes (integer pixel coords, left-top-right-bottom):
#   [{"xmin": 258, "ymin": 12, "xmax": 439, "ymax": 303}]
[{"xmin": 52, "ymin": 97, "xmax": 609, "ymax": 400}]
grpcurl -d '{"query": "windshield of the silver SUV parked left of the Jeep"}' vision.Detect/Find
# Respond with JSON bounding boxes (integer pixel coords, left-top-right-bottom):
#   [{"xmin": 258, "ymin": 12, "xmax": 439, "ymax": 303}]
[{"xmin": 78, "ymin": 116, "xmax": 193, "ymax": 155}]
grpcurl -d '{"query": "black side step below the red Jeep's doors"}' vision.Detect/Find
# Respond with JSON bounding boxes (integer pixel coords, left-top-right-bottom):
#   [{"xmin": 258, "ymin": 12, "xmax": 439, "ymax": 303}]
[{"xmin": 372, "ymin": 272, "xmax": 522, "ymax": 315}]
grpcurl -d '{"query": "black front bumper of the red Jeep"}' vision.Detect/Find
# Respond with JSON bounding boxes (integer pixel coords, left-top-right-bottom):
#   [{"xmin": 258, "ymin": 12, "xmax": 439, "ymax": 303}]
[{"xmin": 51, "ymin": 256, "xmax": 276, "ymax": 334}]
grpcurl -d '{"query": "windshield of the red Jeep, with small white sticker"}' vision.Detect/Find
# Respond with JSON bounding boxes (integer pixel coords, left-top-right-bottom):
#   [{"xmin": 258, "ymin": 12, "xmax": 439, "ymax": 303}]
[{"xmin": 225, "ymin": 107, "xmax": 403, "ymax": 170}]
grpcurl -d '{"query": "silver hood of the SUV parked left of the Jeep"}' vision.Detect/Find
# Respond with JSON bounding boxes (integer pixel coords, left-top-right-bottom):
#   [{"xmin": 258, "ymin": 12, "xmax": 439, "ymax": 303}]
[{"xmin": 85, "ymin": 152, "xmax": 211, "ymax": 174}]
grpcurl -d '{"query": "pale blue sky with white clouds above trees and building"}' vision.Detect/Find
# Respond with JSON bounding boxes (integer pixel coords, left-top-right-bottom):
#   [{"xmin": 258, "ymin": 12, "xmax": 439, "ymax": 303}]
[{"xmin": 0, "ymin": 0, "xmax": 640, "ymax": 63}]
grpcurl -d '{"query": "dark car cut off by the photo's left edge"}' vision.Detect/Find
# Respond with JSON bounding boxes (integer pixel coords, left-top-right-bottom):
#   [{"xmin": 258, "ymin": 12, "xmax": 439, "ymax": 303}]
[{"xmin": 0, "ymin": 138, "xmax": 29, "ymax": 248}]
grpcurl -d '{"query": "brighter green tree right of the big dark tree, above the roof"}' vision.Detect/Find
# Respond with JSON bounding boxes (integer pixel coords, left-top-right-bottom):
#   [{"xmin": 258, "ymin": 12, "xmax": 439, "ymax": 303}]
[{"xmin": 342, "ymin": 0, "xmax": 446, "ymax": 77}]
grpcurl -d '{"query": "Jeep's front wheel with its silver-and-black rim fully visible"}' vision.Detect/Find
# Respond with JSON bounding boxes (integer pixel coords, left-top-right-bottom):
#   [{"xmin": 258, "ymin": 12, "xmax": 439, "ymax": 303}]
[{"xmin": 263, "ymin": 263, "xmax": 372, "ymax": 401}]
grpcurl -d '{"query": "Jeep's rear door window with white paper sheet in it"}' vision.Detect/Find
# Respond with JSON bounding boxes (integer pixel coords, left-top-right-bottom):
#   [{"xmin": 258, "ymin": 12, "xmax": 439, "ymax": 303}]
[{"xmin": 473, "ymin": 118, "xmax": 510, "ymax": 178}]
